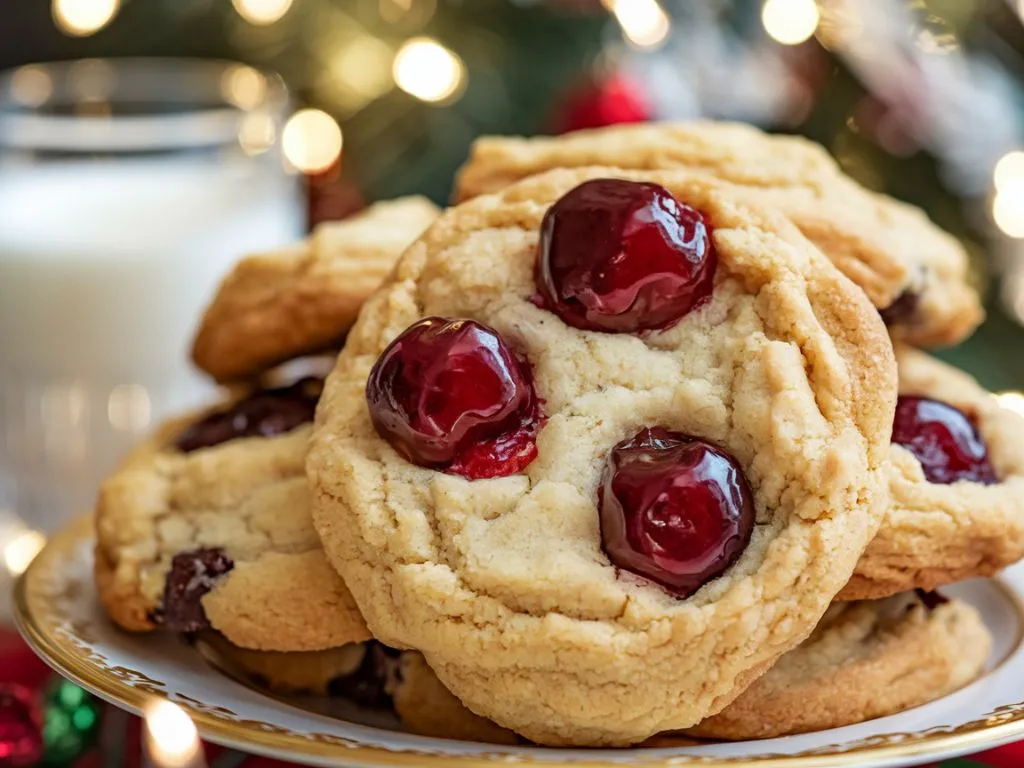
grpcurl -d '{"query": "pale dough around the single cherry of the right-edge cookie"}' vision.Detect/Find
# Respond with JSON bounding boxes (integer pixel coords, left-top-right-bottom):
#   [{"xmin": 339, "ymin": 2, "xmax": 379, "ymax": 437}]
[{"xmin": 840, "ymin": 346, "xmax": 1024, "ymax": 600}]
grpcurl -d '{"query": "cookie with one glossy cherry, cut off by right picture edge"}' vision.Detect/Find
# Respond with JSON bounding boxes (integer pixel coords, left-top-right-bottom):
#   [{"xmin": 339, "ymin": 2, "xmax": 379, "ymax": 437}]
[{"xmin": 840, "ymin": 346, "xmax": 1024, "ymax": 600}]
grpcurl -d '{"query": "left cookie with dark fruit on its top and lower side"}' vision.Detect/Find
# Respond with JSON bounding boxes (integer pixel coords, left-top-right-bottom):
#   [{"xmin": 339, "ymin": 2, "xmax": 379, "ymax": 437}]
[{"xmin": 96, "ymin": 380, "xmax": 370, "ymax": 650}]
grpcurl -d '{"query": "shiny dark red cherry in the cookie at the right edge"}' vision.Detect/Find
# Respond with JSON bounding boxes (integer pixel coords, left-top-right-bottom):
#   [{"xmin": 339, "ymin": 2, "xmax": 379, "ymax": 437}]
[{"xmin": 893, "ymin": 396, "xmax": 998, "ymax": 485}]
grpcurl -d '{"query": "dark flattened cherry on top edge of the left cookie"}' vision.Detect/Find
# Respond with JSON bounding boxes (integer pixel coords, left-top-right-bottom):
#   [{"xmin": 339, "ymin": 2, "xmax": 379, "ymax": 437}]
[{"xmin": 175, "ymin": 378, "xmax": 324, "ymax": 454}]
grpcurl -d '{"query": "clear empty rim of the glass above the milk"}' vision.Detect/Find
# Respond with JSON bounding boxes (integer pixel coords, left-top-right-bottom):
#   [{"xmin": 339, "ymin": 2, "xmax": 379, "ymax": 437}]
[{"xmin": 0, "ymin": 57, "xmax": 291, "ymax": 153}]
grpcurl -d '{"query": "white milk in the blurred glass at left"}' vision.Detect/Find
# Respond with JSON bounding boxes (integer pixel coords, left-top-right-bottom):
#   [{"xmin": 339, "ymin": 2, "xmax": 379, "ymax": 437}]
[{"xmin": 0, "ymin": 155, "xmax": 304, "ymax": 529}]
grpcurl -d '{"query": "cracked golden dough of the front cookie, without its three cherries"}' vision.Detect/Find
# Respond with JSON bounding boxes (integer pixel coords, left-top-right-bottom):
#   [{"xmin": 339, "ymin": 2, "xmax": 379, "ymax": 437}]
[{"xmin": 307, "ymin": 169, "xmax": 896, "ymax": 745}]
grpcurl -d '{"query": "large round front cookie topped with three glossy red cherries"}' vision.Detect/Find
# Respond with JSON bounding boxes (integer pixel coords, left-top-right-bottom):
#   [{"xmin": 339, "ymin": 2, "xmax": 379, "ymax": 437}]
[{"xmin": 307, "ymin": 168, "xmax": 896, "ymax": 745}]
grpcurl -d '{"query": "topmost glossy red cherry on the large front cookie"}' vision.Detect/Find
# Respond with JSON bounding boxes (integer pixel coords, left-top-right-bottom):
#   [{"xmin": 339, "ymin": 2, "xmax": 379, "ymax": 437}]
[{"xmin": 535, "ymin": 178, "xmax": 718, "ymax": 333}]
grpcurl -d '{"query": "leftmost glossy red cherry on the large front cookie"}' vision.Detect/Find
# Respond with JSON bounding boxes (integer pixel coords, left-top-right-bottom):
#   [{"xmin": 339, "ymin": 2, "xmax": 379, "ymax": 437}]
[{"xmin": 367, "ymin": 317, "xmax": 541, "ymax": 480}]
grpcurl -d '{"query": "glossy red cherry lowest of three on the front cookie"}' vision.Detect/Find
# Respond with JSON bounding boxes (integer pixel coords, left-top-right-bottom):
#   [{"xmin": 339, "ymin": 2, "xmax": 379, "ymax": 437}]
[{"xmin": 598, "ymin": 427, "xmax": 754, "ymax": 598}]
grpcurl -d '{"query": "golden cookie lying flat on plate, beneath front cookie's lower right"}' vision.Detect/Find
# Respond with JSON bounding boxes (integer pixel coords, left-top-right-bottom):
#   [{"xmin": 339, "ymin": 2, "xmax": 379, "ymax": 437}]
[{"xmin": 687, "ymin": 592, "xmax": 992, "ymax": 740}]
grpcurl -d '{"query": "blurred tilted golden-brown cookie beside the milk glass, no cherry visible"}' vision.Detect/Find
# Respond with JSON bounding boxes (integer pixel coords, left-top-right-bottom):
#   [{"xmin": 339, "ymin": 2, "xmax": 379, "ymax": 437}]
[{"xmin": 193, "ymin": 197, "xmax": 438, "ymax": 382}]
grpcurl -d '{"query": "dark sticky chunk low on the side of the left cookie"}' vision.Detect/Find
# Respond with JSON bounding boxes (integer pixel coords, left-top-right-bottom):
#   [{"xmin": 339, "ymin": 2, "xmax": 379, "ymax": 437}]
[{"xmin": 159, "ymin": 547, "xmax": 234, "ymax": 632}]
